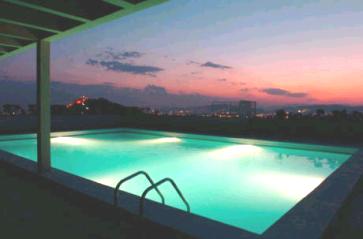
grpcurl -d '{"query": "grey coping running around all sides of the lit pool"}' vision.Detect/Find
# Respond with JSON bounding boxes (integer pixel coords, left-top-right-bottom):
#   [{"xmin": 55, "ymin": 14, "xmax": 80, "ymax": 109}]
[{"xmin": 0, "ymin": 128, "xmax": 363, "ymax": 239}]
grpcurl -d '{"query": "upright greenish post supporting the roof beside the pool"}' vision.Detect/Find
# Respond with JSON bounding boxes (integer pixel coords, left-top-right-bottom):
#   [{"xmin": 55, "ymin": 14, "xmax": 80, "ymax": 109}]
[{"xmin": 37, "ymin": 40, "xmax": 51, "ymax": 172}]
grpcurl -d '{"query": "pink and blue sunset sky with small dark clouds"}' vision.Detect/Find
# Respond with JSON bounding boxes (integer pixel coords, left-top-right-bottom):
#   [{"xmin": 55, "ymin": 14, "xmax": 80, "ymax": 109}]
[{"xmin": 0, "ymin": 0, "xmax": 363, "ymax": 104}]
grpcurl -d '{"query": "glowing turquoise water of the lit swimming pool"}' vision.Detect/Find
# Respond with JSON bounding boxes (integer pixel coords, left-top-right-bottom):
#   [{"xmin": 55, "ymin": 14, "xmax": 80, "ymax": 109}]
[{"xmin": 0, "ymin": 130, "xmax": 350, "ymax": 234}]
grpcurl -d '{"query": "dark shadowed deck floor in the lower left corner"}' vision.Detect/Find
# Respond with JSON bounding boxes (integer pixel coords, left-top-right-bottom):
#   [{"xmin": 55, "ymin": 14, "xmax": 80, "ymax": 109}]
[{"xmin": 0, "ymin": 156, "xmax": 192, "ymax": 239}]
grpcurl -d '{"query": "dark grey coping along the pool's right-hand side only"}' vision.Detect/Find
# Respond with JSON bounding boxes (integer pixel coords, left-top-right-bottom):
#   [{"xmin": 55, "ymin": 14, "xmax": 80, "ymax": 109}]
[{"xmin": 261, "ymin": 148, "xmax": 363, "ymax": 239}]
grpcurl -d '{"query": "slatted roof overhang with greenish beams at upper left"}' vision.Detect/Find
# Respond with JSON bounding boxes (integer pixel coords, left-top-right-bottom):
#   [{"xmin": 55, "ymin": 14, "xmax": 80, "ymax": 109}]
[{"xmin": 0, "ymin": 0, "xmax": 168, "ymax": 59}]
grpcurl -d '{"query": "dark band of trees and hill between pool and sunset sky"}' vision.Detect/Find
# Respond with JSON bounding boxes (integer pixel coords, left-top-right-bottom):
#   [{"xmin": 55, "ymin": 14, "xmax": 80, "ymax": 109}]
[{"xmin": 2, "ymin": 98, "xmax": 363, "ymax": 146}]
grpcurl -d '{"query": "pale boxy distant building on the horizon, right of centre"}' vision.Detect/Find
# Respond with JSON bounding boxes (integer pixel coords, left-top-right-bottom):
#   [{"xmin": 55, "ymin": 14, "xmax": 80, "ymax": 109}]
[{"xmin": 211, "ymin": 100, "xmax": 256, "ymax": 119}]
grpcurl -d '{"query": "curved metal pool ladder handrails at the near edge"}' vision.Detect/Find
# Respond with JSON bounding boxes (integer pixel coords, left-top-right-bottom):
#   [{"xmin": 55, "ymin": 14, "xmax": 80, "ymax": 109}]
[{"xmin": 113, "ymin": 171, "xmax": 190, "ymax": 216}]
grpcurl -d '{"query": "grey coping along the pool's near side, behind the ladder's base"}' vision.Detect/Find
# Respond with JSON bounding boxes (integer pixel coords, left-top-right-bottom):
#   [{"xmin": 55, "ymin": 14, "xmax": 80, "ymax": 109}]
[{"xmin": 0, "ymin": 150, "xmax": 259, "ymax": 239}]
